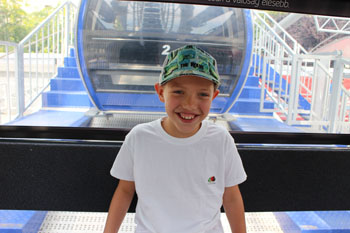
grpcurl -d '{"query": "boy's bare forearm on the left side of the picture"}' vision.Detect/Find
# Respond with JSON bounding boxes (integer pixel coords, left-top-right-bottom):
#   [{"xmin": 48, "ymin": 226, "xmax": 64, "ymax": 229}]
[{"xmin": 104, "ymin": 180, "xmax": 135, "ymax": 233}]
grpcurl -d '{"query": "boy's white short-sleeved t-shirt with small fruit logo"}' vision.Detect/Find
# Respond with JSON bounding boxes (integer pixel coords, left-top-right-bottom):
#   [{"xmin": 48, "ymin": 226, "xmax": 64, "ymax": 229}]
[{"xmin": 111, "ymin": 119, "xmax": 247, "ymax": 233}]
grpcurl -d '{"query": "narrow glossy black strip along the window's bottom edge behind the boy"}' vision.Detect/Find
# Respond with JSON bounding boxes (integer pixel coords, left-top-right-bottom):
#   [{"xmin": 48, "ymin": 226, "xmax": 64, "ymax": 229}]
[{"xmin": 0, "ymin": 126, "xmax": 350, "ymax": 145}]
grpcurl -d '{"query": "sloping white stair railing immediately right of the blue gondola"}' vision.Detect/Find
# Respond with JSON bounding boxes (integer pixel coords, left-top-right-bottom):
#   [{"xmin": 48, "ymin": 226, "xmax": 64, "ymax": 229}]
[{"xmin": 252, "ymin": 10, "xmax": 307, "ymax": 116}]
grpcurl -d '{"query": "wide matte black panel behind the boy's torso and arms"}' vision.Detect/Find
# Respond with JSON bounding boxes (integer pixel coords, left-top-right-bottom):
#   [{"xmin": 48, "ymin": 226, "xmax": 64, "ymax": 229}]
[{"xmin": 0, "ymin": 140, "xmax": 350, "ymax": 212}]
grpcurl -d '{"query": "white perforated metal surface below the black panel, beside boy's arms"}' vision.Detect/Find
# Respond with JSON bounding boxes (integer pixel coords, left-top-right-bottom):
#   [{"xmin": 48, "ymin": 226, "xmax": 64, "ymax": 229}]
[{"xmin": 38, "ymin": 211, "xmax": 283, "ymax": 233}]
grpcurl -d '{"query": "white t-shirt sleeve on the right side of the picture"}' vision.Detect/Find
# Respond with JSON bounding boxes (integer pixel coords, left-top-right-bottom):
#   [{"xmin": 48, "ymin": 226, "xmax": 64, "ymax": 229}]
[{"xmin": 225, "ymin": 139, "xmax": 247, "ymax": 187}]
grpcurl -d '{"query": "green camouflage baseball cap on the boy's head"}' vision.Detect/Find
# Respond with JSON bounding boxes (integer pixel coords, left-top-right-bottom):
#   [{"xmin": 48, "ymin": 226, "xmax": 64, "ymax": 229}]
[{"xmin": 159, "ymin": 45, "xmax": 220, "ymax": 86}]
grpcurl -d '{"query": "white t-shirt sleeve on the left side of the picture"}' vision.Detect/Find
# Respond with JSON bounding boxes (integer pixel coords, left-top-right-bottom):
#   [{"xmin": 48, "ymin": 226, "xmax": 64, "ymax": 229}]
[{"xmin": 111, "ymin": 138, "xmax": 134, "ymax": 181}]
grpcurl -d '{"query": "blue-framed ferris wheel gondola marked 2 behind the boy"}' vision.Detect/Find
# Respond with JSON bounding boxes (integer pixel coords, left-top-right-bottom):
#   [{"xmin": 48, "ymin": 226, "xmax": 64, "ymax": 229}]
[{"xmin": 76, "ymin": 0, "xmax": 252, "ymax": 113}]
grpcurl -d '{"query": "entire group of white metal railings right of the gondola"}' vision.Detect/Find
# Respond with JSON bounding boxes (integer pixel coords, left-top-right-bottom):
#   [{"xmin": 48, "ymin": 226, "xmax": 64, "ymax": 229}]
[{"xmin": 252, "ymin": 11, "xmax": 350, "ymax": 133}]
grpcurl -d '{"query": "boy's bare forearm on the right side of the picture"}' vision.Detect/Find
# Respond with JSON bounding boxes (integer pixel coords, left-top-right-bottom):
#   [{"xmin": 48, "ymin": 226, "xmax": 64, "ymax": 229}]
[{"xmin": 223, "ymin": 185, "xmax": 246, "ymax": 233}]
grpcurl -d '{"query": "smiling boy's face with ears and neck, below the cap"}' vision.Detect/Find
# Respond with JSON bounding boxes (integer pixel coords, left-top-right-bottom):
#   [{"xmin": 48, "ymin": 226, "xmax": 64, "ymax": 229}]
[{"xmin": 155, "ymin": 76, "xmax": 219, "ymax": 138}]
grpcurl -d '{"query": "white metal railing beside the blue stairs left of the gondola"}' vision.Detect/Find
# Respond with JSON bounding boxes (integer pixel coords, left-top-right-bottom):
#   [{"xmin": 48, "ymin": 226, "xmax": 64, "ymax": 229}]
[{"xmin": 0, "ymin": 0, "xmax": 76, "ymax": 124}]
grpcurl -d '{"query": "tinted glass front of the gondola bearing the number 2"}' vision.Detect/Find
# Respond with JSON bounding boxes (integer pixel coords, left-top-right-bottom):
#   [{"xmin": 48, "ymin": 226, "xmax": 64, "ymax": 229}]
[{"xmin": 83, "ymin": 0, "xmax": 245, "ymax": 95}]
